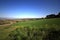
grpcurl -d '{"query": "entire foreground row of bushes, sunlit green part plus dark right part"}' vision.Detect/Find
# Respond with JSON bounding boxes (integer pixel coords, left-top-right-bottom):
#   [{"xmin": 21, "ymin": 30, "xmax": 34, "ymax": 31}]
[{"xmin": 9, "ymin": 27, "xmax": 60, "ymax": 40}]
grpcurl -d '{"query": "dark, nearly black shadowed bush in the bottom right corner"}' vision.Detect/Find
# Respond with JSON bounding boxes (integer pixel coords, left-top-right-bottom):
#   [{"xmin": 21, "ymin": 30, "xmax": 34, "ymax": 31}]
[{"xmin": 43, "ymin": 29, "xmax": 60, "ymax": 40}]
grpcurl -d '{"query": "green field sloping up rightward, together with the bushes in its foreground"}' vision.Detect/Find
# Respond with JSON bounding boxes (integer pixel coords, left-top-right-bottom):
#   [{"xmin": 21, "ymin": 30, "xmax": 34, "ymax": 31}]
[{"xmin": 0, "ymin": 18, "xmax": 60, "ymax": 40}]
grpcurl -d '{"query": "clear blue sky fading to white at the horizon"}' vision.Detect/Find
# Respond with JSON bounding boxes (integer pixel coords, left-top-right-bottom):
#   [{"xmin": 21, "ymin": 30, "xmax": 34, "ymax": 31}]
[{"xmin": 0, "ymin": 0, "xmax": 60, "ymax": 18}]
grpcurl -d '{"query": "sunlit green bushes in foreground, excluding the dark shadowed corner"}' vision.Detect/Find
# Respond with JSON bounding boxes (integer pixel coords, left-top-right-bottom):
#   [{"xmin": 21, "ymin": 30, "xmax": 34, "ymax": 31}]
[{"xmin": 9, "ymin": 27, "xmax": 43, "ymax": 40}]
